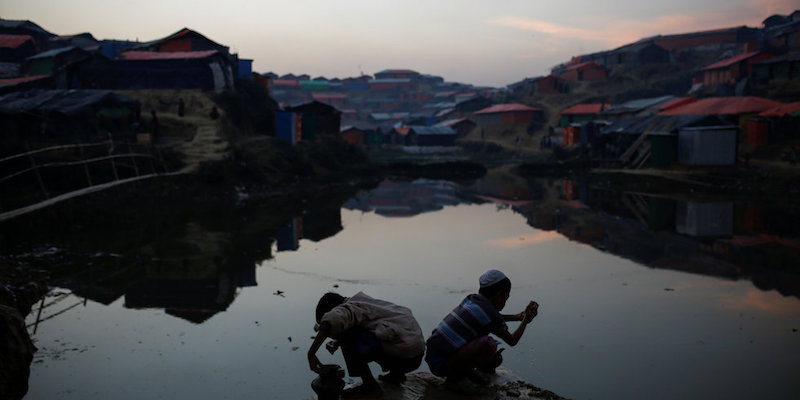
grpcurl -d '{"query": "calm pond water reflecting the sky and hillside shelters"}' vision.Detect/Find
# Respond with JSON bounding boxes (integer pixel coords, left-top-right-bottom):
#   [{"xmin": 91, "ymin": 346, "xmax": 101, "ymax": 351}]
[{"xmin": 15, "ymin": 176, "xmax": 800, "ymax": 399}]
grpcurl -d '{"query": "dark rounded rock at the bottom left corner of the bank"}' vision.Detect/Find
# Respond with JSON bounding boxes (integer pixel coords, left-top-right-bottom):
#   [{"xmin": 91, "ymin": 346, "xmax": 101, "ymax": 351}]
[{"xmin": 0, "ymin": 305, "xmax": 36, "ymax": 400}]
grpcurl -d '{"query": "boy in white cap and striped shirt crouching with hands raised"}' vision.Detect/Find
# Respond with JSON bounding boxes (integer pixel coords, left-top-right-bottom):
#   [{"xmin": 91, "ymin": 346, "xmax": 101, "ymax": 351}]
[{"xmin": 425, "ymin": 269, "xmax": 539, "ymax": 391}]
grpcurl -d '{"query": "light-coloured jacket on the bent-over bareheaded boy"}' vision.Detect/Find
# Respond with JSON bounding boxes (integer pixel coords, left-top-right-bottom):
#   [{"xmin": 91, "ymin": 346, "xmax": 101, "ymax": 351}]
[{"xmin": 320, "ymin": 292, "xmax": 425, "ymax": 358}]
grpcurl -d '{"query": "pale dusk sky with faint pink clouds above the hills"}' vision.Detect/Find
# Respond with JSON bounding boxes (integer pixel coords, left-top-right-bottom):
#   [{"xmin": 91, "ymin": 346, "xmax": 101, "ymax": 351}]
[{"xmin": 0, "ymin": 0, "xmax": 800, "ymax": 86}]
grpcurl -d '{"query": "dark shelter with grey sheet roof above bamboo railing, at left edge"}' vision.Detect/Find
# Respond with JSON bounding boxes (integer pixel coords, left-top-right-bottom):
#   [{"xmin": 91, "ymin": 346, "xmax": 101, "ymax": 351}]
[{"xmin": 0, "ymin": 90, "xmax": 139, "ymax": 153}]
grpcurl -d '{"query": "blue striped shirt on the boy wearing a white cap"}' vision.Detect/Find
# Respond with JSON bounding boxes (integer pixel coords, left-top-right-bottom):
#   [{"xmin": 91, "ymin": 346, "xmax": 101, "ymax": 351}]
[{"xmin": 427, "ymin": 294, "xmax": 508, "ymax": 355}]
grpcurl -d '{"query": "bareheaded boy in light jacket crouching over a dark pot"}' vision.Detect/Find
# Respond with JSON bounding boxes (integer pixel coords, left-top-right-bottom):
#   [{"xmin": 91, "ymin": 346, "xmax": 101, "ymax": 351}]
[{"xmin": 308, "ymin": 292, "xmax": 425, "ymax": 398}]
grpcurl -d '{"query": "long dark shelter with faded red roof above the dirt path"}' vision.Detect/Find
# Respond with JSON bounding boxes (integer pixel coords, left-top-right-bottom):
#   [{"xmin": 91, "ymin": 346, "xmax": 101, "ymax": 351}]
[{"xmin": 116, "ymin": 50, "xmax": 233, "ymax": 91}]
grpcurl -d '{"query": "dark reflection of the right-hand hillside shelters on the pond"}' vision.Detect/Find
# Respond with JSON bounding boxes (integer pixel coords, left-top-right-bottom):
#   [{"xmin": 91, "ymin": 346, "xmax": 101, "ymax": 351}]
[{"xmin": 515, "ymin": 179, "xmax": 800, "ymax": 297}]
